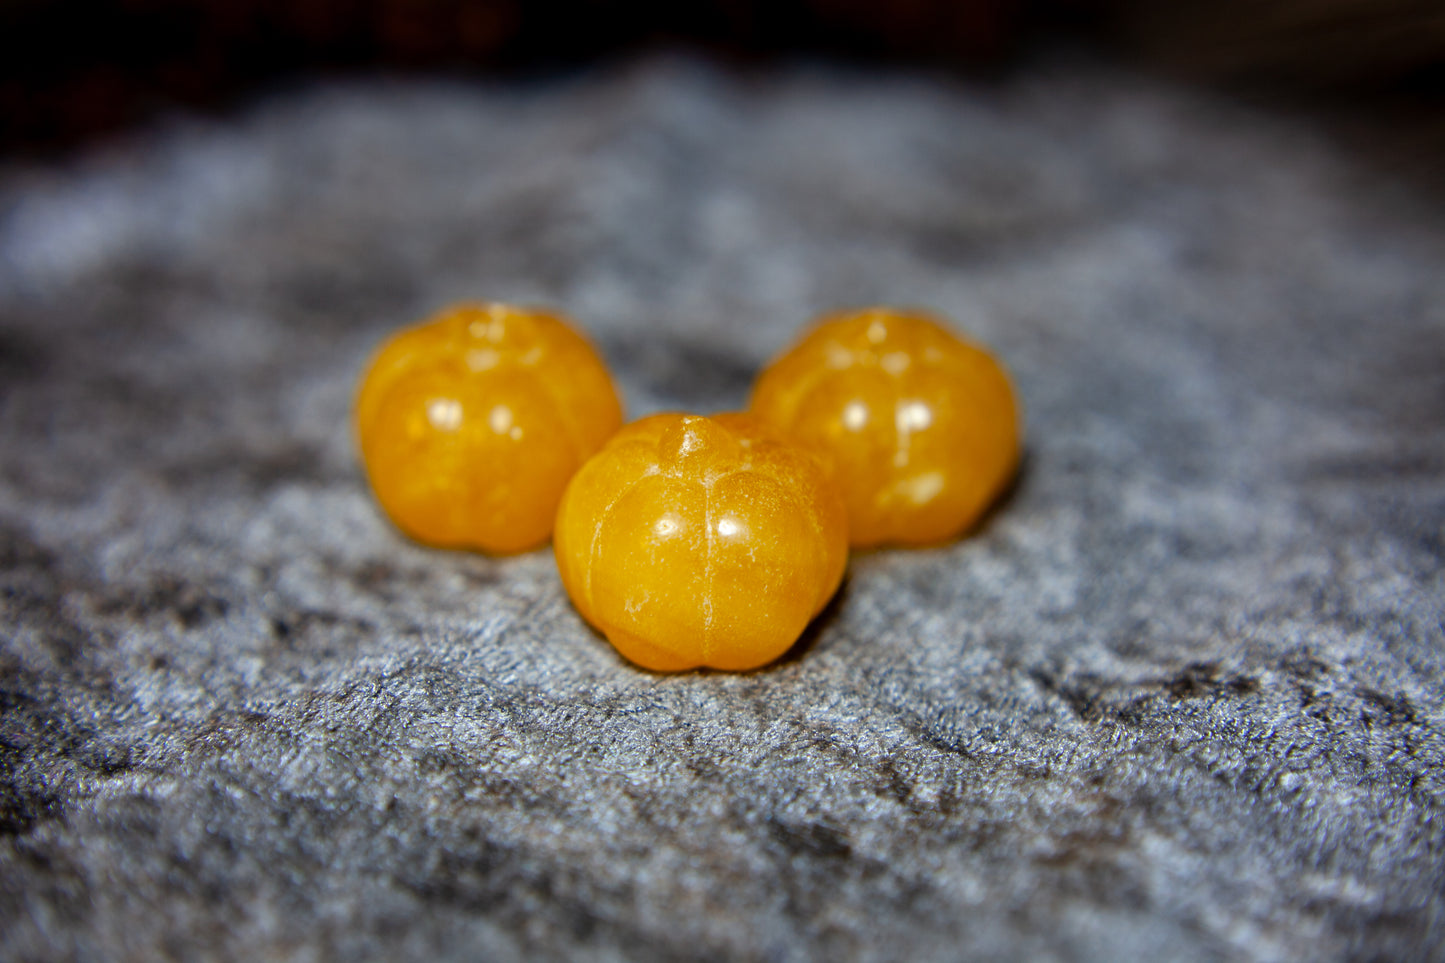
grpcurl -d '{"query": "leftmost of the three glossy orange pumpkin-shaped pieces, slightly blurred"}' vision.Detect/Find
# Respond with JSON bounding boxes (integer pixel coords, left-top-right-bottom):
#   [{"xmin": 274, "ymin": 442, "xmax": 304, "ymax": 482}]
[{"xmin": 355, "ymin": 304, "xmax": 621, "ymax": 552}]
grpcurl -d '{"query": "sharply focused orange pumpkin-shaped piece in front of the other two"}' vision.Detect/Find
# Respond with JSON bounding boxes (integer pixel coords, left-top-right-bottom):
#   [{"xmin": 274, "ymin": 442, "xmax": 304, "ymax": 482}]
[{"xmin": 553, "ymin": 414, "xmax": 848, "ymax": 671}]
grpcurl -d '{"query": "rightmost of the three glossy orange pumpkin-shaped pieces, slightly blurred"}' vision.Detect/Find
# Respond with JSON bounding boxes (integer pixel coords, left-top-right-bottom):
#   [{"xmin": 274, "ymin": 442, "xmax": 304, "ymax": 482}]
[{"xmin": 750, "ymin": 308, "xmax": 1022, "ymax": 547}]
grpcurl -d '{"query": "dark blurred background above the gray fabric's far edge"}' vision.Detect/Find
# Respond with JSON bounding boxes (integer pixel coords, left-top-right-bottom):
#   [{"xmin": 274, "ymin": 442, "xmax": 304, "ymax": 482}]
[{"xmin": 0, "ymin": 0, "xmax": 1445, "ymax": 153}]
